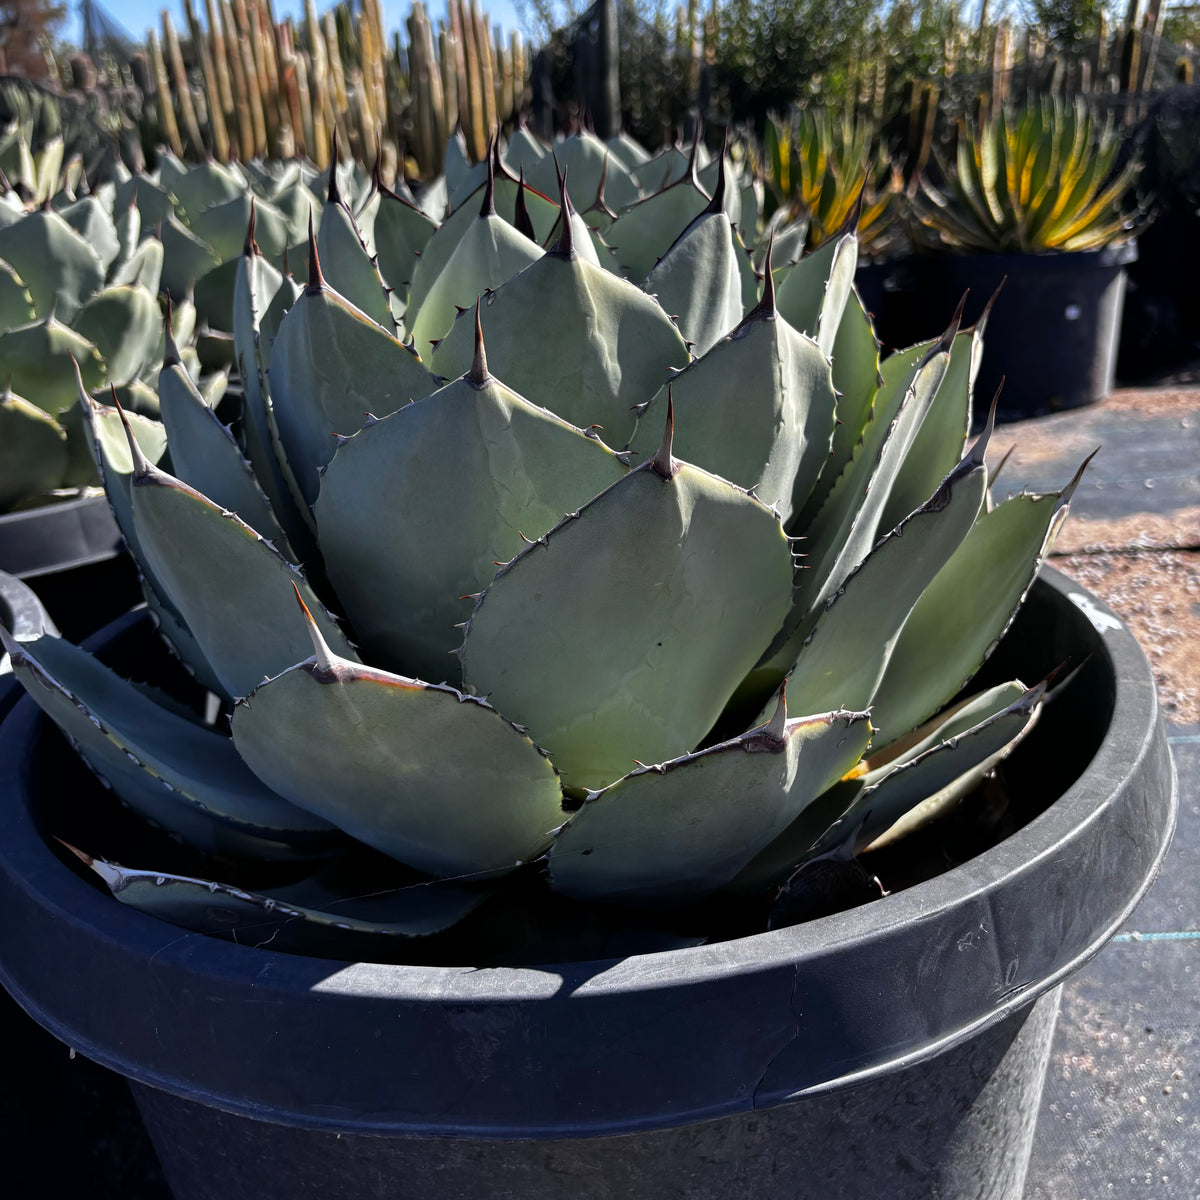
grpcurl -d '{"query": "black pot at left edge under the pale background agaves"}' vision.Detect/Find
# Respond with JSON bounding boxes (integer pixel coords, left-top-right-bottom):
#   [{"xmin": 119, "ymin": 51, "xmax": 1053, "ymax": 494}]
[{"xmin": 0, "ymin": 496, "xmax": 142, "ymax": 642}]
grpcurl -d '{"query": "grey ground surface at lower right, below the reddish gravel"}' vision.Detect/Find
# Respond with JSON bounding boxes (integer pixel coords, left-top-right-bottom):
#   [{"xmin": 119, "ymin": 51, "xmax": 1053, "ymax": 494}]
[{"xmin": 1025, "ymin": 725, "xmax": 1200, "ymax": 1200}]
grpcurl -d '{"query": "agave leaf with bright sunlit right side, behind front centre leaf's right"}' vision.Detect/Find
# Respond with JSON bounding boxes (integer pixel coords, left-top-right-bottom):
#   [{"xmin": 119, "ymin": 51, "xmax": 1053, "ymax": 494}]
[{"xmin": 631, "ymin": 285, "xmax": 836, "ymax": 523}]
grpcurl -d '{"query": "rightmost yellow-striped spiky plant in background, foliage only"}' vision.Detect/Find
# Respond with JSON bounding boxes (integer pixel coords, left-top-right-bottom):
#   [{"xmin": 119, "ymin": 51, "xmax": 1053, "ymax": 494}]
[{"xmin": 912, "ymin": 97, "xmax": 1138, "ymax": 254}]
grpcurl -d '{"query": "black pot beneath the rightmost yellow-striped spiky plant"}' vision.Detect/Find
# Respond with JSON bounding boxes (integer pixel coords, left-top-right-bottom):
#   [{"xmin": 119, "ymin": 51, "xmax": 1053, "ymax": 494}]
[{"xmin": 890, "ymin": 241, "xmax": 1138, "ymax": 419}]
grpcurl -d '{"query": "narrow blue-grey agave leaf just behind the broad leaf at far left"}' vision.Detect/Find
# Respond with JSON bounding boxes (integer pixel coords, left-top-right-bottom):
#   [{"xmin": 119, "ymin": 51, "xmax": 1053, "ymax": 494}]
[{"xmin": 158, "ymin": 348, "xmax": 295, "ymax": 552}]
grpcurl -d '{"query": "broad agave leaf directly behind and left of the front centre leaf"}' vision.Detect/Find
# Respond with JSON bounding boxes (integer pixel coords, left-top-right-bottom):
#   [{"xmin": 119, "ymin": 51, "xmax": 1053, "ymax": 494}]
[{"xmin": 316, "ymin": 343, "xmax": 625, "ymax": 683}]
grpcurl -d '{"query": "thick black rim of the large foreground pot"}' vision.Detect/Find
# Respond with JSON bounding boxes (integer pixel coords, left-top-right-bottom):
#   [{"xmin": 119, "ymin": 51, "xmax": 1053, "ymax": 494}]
[{"xmin": 0, "ymin": 561, "xmax": 1176, "ymax": 1138}]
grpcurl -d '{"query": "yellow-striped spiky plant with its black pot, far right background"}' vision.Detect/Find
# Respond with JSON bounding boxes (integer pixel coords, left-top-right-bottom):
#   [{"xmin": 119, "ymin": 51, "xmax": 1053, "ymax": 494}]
[{"xmin": 911, "ymin": 98, "xmax": 1136, "ymax": 415}]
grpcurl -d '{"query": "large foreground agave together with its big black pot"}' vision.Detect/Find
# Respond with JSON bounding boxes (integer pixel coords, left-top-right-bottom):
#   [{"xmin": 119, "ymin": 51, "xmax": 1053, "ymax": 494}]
[{"xmin": 0, "ymin": 131, "xmax": 1174, "ymax": 1200}]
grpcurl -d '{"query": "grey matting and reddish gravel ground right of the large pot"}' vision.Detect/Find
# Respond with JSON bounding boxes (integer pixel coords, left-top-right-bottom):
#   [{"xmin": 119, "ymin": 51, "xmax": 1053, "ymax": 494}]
[{"xmin": 992, "ymin": 388, "xmax": 1200, "ymax": 1200}]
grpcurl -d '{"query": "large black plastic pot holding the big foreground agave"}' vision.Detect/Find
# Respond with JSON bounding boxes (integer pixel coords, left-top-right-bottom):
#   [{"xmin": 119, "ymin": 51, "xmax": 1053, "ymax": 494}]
[{"xmin": 0, "ymin": 571, "xmax": 1176, "ymax": 1200}]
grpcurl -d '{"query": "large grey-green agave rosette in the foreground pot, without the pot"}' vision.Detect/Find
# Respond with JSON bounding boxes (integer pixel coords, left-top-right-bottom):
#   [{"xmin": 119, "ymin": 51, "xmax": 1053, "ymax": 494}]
[{"xmin": 8, "ymin": 138, "xmax": 1089, "ymax": 961}]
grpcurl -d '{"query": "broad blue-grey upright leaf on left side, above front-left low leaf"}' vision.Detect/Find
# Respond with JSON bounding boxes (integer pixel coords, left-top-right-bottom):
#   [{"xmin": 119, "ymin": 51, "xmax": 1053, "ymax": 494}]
[{"xmin": 120, "ymin": 434, "xmax": 354, "ymax": 696}]
